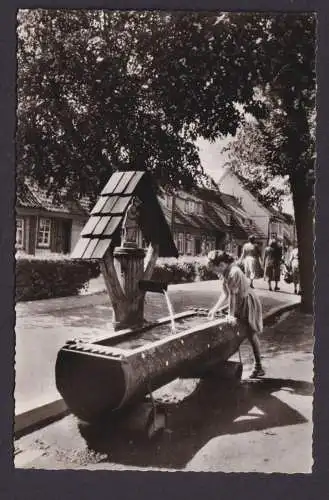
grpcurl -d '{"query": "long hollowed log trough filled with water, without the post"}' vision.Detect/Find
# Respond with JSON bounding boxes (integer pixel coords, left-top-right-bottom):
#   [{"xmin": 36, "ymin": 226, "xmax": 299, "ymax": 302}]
[{"xmin": 56, "ymin": 309, "xmax": 246, "ymax": 422}]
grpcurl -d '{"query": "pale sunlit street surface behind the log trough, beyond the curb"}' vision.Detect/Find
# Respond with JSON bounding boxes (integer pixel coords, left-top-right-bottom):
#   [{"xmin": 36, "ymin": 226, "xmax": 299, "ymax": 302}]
[{"xmin": 15, "ymin": 277, "xmax": 300, "ymax": 432}]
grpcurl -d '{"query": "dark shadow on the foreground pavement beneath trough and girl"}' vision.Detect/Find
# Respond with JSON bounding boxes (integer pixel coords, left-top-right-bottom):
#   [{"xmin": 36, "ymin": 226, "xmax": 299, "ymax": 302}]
[{"xmin": 80, "ymin": 378, "xmax": 313, "ymax": 469}]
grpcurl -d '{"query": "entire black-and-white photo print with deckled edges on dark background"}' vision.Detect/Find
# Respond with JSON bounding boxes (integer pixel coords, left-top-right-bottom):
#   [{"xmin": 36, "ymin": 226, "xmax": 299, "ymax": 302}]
[{"xmin": 13, "ymin": 8, "xmax": 317, "ymax": 474}]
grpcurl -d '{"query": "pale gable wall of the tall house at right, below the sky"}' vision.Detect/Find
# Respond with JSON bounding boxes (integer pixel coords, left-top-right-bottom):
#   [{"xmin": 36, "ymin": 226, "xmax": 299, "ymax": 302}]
[{"xmin": 218, "ymin": 172, "xmax": 270, "ymax": 237}]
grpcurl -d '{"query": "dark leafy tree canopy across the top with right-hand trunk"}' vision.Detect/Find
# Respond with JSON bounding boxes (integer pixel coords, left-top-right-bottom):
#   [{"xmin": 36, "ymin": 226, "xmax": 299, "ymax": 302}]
[{"xmin": 17, "ymin": 10, "xmax": 315, "ymax": 310}]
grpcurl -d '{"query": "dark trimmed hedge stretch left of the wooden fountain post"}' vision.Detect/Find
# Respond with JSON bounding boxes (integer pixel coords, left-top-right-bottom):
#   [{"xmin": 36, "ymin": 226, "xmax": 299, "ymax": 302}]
[{"xmin": 16, "ymin": 257, "xmax": 100, "ymax": 302}]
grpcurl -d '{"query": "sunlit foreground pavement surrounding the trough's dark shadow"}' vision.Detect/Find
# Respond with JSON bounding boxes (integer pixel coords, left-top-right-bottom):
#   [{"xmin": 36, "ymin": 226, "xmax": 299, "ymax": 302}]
[{"xmin": 15, "ymin": 304, "xmax": 313, "ymax": 473}]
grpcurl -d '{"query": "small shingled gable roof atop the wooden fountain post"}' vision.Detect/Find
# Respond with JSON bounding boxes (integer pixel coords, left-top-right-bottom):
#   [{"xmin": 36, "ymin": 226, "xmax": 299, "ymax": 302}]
[{"xmin": 72, "ymin": 171, "xmax": 178, "ymax": 259}]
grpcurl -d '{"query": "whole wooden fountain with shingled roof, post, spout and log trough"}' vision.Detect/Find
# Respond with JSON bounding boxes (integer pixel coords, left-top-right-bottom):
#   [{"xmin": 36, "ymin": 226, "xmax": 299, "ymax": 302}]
[{"xmin": 56, "ymin": 171, "xmax": 246, "ymax": 434}]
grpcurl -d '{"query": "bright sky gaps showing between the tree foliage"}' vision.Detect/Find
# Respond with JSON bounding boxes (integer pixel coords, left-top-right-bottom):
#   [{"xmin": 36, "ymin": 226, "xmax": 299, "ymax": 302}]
[{"xmin": 197, "ymin": 136, "xmax": 294, "ymax": 215}]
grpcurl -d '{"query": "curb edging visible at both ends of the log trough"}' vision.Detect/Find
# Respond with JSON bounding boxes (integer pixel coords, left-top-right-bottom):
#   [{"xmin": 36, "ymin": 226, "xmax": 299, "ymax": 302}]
[{"xmin": 14, "ymin": 303, "xmax": 300, "ymax": 439}]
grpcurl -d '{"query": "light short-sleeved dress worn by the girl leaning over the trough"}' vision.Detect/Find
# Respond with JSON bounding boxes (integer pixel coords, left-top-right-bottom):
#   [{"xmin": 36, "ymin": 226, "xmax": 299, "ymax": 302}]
[{"xmin": 223, "ymin": 264, "xmax": 263, "ymax": 333}]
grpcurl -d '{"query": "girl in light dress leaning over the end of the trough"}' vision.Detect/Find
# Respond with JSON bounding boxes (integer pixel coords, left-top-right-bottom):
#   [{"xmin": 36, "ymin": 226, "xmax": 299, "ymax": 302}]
[{"xmin": 208, "ymin": 250, "xmax": 265, "ymax": 378}]
